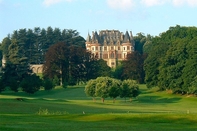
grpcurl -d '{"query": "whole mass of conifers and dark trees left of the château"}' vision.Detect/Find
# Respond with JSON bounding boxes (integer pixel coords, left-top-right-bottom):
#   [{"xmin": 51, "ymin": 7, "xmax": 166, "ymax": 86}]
[{"xmin": 0, "ymin": 27, "xmax": 111, "ymax": 93}]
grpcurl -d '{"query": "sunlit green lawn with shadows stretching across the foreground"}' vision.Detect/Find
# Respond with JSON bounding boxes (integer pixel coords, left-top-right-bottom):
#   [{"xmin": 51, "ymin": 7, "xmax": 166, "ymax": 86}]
[{"xmin": 0, "ymin": 85, "xmax": 197, "ymax": 131}]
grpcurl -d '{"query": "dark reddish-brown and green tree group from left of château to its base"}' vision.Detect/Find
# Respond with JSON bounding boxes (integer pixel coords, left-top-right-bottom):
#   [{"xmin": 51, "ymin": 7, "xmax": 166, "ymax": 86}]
[{"xmin": 43, "ymin": 43, "xmax": 111, "ymax": 86}]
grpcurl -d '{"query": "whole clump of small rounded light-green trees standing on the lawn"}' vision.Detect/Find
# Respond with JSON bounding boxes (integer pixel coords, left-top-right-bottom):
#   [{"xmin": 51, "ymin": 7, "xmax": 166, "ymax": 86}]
[{"xmin": 85, "ymin": 77, "xmax": 140, "ymax": 102}]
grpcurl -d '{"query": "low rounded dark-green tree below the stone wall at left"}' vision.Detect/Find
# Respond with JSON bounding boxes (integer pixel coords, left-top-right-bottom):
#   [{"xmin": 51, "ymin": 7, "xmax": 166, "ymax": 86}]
[{"xmin": 20, "ymin": 74, "xmax": 42, "ymax": 94}]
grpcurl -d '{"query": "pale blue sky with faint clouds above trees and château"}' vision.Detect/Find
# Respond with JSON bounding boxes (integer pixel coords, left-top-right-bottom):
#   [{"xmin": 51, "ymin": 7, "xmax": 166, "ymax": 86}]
[{"xmin": 0, "ymin": 0, "xmax": 197, "ymax": 42}]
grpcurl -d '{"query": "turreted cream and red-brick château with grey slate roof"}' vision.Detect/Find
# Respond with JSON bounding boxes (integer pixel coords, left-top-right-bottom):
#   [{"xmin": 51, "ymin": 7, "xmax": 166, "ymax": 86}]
[{"xmin": 86, "ymin": 30, "xmax": 135, "ymax": 68}]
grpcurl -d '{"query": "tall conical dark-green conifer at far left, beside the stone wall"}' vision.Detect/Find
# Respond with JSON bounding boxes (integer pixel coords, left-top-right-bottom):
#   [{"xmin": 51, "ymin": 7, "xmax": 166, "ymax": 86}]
[{"xmin": 2, "ymin": 40, "xmax": 31, "ymax": 92}]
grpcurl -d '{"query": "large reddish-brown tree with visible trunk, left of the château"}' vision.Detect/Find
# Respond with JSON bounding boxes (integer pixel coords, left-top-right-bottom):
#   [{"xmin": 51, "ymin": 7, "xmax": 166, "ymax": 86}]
[{"xmin": 43, "ymin": 43, "xmax": 69, "ymax": 85}]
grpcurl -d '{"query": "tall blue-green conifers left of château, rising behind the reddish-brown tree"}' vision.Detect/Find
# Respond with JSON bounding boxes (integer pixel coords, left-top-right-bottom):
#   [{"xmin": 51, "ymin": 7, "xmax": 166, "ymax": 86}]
[{"xmin": 1, "ymin": 27, "xmax": 85, "ymax": 64}]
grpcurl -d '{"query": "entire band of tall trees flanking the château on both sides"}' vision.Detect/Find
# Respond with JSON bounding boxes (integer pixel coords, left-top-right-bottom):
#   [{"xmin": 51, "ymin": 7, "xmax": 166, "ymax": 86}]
[{"xmin": 0, "ymin": 25, "xmax": 197, "ymax": 94}]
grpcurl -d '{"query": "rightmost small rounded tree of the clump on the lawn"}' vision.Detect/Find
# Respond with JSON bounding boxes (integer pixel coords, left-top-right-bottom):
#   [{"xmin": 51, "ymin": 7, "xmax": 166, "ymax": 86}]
[{"xmin": 120, "ymin": 80, "xmax": 140, "ymax": 101}]
